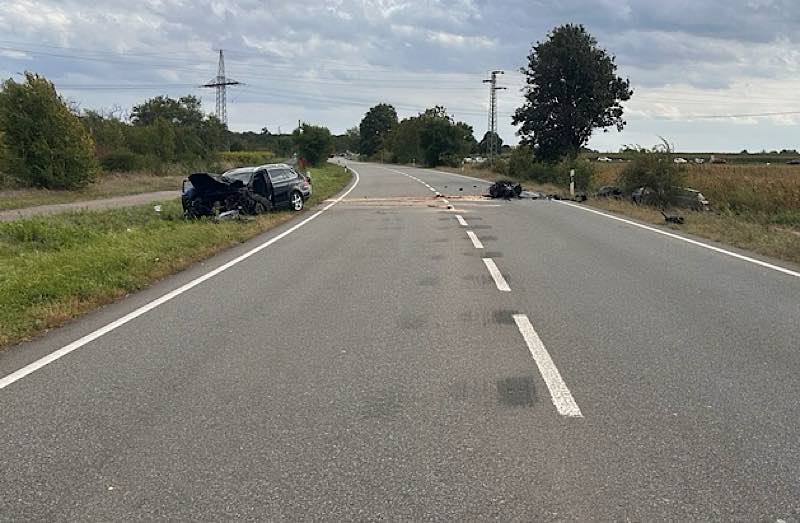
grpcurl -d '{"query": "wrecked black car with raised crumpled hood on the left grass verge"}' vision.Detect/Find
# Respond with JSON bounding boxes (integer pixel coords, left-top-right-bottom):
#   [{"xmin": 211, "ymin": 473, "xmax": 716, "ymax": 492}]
[{"xmin": 181, "ymin": 164, "xmax": 311, "ymax": 218}]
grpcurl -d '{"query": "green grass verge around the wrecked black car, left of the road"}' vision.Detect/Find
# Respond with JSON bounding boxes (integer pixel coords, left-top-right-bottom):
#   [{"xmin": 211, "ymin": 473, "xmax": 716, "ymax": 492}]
[{"xmin": 0, "ymin": 165, "xmax": 350, "ymax": 347}]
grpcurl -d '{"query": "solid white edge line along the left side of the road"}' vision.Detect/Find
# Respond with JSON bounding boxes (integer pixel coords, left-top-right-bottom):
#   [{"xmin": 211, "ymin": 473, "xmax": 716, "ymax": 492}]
[{"xmin": 0, "ymin": 167, "xmax": 360, "ymax": 390}]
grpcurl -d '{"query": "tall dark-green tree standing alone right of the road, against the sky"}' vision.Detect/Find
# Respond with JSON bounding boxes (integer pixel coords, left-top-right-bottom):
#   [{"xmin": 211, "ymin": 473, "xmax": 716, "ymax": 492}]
[{"xmin": 513, "ymin": 24, "xmax": 633, "ymax": 162}]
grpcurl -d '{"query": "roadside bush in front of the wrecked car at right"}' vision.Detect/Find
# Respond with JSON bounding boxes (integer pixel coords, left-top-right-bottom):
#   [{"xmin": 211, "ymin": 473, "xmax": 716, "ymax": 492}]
[{"xmin": 617, "ymin": 141, "xmax": 687, "ymax": 205}]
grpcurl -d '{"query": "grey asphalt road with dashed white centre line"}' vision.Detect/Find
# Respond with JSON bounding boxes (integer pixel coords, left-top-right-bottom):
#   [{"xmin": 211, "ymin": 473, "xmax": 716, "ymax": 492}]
[{"xmin": 0, "ymin": 164, "xmax": 800, "ymax": 522}]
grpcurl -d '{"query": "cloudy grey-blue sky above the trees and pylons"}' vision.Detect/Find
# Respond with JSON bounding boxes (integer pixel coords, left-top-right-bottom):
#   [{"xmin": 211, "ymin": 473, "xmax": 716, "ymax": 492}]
[{"xmin": 0, "ymin": 0, "xmax": 800, "ymax": 151}]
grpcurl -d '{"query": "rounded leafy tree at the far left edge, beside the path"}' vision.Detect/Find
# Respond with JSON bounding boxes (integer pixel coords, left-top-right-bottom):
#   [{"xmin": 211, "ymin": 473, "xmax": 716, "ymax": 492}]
[{"xmin": 0, "ymin": 73, "xmax": 98, "ymax": 189}]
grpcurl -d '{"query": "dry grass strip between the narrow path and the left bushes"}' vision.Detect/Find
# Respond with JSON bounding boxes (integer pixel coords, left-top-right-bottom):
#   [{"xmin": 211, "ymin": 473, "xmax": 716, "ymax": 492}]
[{"xmin": 0, "ymin": 173, "xmax": 184, "ymax": 211}]
